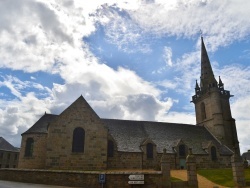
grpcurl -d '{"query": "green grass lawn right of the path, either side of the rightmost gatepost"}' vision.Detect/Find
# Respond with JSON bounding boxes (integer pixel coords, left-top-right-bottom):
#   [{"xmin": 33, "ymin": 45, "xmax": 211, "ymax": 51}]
[{"xmin": 198, "ymin": 168, "xmax": 250, "ymax": 187}]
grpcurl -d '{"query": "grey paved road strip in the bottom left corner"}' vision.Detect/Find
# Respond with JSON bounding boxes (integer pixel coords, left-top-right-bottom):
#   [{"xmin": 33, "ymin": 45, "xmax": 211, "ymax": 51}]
[{"xmin": 0, "ymin": 180, "xmax": 75, "ymax": 188}]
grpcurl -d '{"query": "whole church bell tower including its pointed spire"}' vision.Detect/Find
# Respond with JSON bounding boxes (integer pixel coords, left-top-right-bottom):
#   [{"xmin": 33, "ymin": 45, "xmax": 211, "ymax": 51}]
[{"xmin": 192, "ymin": 37, "xmax": 239, "ymax": 152}]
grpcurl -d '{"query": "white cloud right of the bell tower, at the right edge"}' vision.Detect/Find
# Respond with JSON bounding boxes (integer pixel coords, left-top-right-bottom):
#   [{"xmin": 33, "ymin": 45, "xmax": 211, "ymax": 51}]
[{"xmin": 220, "ymin": 65, "xmax": 250, "ymax": 153}]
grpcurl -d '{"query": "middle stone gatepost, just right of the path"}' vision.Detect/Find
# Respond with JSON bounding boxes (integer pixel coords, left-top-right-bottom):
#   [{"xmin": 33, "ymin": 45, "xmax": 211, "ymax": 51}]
[{"xmin": 186, "ymin": 148, "xmax": 198, "ymax": 188}]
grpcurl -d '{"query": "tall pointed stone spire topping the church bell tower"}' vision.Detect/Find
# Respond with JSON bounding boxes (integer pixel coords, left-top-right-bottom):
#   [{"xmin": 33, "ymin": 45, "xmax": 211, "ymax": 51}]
[{"xmin": 201, "ymin": 36, "xmax": 217, "ymax": 90}]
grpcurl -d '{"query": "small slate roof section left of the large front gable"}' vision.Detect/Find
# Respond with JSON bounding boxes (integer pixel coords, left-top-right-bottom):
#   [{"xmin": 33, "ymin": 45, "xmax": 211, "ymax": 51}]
[{"xmin": 22, "ymin": 114, "xmax": 58, "ymax": 135}]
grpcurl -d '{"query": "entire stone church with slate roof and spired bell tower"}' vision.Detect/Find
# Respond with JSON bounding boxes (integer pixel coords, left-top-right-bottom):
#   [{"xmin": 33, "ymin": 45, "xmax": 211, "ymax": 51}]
[{"xmin": 18, "ymin": 37, "xmax": 239, "ymax": 170}]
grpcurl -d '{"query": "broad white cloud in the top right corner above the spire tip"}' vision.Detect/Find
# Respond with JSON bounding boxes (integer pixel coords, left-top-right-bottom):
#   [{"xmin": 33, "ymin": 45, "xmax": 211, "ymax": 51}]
[{"xmin": 124, "ymin": 0, "xmax": 250, "ymax": 51}]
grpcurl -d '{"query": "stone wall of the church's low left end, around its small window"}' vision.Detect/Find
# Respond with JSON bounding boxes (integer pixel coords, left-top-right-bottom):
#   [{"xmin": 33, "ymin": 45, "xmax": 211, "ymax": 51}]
[{"xmin": 18, "ymin": 134, "xmax": 47, "ymax": 169}]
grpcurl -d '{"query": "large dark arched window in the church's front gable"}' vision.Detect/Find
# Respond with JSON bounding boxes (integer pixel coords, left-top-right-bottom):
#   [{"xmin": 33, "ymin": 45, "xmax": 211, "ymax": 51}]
[{"xmin": 72, "ymin": 127, "xmax": 85, "ymax": 152}]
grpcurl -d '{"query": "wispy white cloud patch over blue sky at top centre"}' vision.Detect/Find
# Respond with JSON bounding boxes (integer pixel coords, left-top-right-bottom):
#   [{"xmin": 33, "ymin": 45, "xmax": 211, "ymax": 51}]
[{"xmin": 96, "ymin": 6, "xmax": 152, "ymax": 53}]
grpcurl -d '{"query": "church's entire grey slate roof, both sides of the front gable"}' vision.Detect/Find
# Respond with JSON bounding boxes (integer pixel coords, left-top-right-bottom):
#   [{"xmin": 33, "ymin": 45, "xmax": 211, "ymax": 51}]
[{"xmin": 23, "ymin": 114, "xmax": 232, "ymax": 155}]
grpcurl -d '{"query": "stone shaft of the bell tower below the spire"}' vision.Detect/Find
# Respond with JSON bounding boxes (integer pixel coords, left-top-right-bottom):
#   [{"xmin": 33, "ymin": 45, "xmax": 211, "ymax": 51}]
[{"xmin": 195, "ymin": 88, "xmax": 238, "ymax": 153}]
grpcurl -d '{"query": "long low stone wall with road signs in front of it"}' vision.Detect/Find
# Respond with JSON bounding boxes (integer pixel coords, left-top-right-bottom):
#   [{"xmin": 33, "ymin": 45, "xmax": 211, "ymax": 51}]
[{"xmin": 0, "ymin": 169, "xmax": 162, "ymax": 188}]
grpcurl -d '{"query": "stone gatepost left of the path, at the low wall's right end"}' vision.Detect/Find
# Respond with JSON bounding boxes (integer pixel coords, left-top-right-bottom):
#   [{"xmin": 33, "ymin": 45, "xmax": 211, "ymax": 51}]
[{"xmin": 161, "ymin": 149, "xmax": 171, "ymax": 188}]
